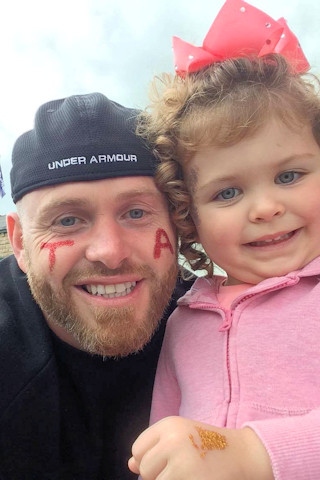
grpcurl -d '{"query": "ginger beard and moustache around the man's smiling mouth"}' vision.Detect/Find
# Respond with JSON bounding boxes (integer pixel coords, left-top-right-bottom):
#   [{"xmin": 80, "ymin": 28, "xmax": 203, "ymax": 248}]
[{"xmin": 25, "ymin": 249, "xmax": 177, "ymax": 357}]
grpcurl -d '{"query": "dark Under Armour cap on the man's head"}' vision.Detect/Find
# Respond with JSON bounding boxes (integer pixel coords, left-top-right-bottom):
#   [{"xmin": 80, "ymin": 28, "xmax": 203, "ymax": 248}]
[{"xmin": 10, "ymin": 93, "xmax": 157, "ymax": 202}]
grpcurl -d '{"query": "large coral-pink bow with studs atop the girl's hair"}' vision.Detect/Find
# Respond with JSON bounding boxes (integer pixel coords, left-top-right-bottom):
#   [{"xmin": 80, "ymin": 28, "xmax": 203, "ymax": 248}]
[{"xmin": 173, "ymin": 0, "xmax": 310, "ymax": 77}]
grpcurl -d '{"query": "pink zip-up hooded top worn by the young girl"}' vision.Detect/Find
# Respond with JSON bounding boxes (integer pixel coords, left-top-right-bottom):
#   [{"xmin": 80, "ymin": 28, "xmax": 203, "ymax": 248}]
[{"xmin": 151, "ymin": 257, "xmax": 320, "ymax": 480}]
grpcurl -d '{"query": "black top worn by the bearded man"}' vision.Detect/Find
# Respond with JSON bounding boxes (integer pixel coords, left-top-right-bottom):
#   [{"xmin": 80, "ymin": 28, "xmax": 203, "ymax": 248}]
[{"xmin": 0, "ymin": 256, "xmax": 190, "ymax": 480}]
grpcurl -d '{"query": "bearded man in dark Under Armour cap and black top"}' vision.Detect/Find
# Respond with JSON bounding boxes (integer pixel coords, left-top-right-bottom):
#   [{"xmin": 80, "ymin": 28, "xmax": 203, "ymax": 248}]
[{"xmin": 0, "ymin": 93, "xmax": 191, "ymax": 480}]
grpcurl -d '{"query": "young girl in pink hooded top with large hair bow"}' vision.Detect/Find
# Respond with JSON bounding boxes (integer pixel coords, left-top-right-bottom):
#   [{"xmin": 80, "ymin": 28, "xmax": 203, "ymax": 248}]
[{"xmin": 129, "ymin": 0, "xmax": 320, "ymax": 480}]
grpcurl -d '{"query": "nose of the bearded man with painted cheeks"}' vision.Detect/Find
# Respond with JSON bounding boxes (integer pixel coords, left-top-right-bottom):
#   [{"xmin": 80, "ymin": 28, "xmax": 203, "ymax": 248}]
[{"xmin": 86, "ymin": 220, "xmax": 131, "ymax": 269}]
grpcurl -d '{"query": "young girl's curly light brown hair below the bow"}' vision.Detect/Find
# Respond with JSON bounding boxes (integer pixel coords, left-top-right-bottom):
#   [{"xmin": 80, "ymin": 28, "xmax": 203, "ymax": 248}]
[{"xmin": 137, "ymin": 54, "xmax": 320, "ymax": 276}]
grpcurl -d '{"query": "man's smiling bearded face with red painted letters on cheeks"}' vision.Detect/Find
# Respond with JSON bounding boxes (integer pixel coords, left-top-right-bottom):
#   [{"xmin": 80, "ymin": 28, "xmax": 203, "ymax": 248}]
[{"xmin": 15, "ymin": 177, "xmax": 177, "ymax": 356}]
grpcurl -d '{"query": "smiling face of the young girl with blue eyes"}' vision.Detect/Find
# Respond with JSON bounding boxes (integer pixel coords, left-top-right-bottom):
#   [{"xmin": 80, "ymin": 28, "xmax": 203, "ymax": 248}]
[{"xmin": 185, "ymin": 118, "xmax": 320, "ymax": 284}]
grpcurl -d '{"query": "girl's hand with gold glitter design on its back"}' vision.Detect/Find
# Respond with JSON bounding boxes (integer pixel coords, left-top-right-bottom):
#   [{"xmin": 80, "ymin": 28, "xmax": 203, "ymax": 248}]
[{"xmin": 128, "ymin": 417, "xmax": 274, "ymax": 480}]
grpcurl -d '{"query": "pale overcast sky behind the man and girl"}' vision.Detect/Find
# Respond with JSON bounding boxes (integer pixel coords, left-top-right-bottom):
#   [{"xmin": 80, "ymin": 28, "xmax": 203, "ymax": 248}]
[{"xmin": 0, "ymin": 0, "xmax": 320, "ymax": 215}]
